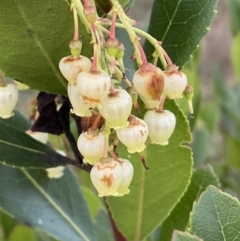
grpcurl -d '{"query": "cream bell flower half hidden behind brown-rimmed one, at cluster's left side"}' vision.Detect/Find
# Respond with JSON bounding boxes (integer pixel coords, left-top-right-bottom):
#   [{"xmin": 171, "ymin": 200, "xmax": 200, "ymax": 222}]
[{"xmin": 67, "ymin": 84, "xmax": 92, "ymax": 117}]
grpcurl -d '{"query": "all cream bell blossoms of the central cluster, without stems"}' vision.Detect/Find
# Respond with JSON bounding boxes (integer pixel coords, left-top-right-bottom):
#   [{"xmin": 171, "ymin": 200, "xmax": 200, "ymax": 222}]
[{"xmin": 59, "ymin": 46, "xmax": 187, "ymax": 196}]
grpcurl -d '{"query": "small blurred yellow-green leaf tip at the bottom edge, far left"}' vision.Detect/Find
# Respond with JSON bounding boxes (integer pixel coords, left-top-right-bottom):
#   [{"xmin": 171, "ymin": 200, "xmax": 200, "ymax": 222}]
[{"xmin": 8, "ymin": 224, "xmax": 37, "ymax": 241}]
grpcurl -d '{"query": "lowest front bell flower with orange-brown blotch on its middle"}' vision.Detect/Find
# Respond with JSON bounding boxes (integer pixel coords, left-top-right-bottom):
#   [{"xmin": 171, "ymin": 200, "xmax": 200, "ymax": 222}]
[{"xmin": 90, "ymin": 158, "xmax": 122, "ymax": 197}]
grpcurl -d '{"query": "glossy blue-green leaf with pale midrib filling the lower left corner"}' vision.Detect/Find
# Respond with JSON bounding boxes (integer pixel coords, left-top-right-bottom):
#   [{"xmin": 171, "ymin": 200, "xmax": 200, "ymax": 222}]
[{"xmin": 0, "ymin": 165, "xmax": 95, "ymax": 241}]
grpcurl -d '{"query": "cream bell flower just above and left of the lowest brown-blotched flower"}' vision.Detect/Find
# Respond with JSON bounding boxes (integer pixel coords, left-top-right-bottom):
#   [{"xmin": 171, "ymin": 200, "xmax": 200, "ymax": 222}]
[{"xmin": 77, "ymin": 128, "xmax": 104, "ymax": 165}]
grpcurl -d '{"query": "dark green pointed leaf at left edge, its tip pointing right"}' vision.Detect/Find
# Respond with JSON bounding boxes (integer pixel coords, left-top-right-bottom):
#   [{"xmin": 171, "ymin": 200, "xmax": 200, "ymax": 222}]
[{"xmin": 0, "ymin": 114, "xmax": 72, "ymax": 168}]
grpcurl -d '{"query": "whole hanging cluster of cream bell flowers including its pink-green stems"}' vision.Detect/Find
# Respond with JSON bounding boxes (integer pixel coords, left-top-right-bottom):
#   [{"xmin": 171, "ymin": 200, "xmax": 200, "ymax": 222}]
[{"xmin": 53, "ymin": 0, "xmax": 193, "ymax": 196}]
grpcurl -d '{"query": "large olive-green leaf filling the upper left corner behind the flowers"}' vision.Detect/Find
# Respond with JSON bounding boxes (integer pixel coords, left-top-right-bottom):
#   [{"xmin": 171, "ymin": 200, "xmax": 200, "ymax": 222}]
[{"xmin": 0, "ymin": 0, "xmax": 91, "ymax": 94}]
